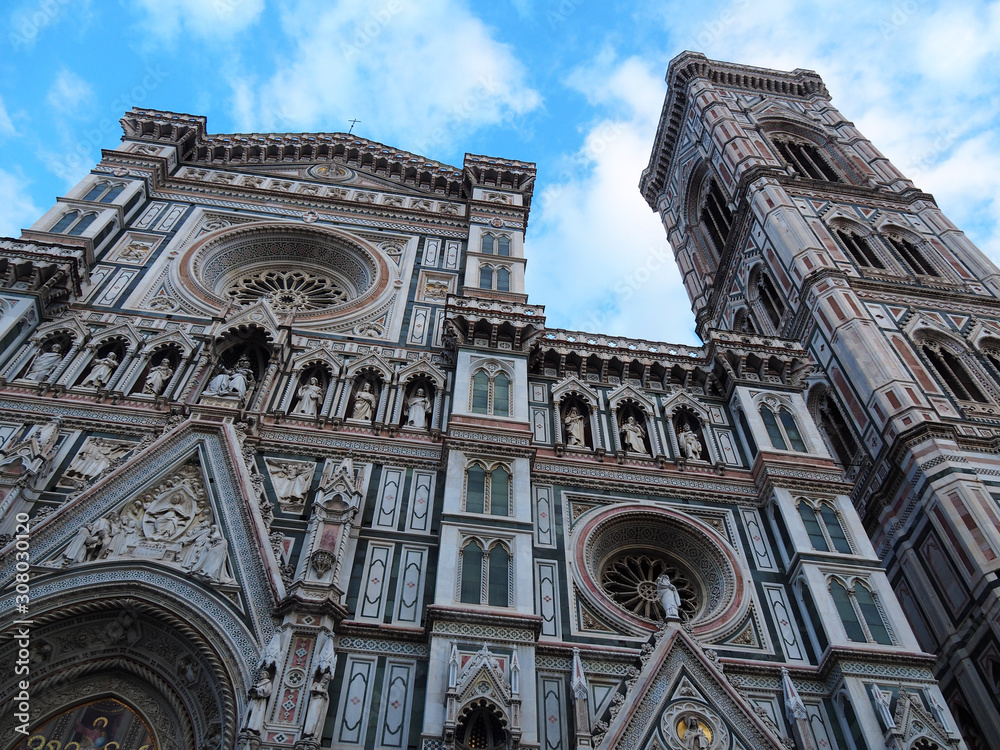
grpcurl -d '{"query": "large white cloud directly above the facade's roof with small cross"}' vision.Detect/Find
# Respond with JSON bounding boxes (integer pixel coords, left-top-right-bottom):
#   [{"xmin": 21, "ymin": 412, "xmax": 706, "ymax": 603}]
[{"xmin": 231, "ymin": 0, "xmax": 541, "ymax": 158}]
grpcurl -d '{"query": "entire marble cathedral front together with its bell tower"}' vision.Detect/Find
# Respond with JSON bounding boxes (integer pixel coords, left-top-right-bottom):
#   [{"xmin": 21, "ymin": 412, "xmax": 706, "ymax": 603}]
[{"xmin": 0, "ymin": 53, "xmax": 984, "ymax": 750}]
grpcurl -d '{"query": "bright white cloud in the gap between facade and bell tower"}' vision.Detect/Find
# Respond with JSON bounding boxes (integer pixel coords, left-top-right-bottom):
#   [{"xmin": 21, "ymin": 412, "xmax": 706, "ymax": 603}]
[{"xmin": 525, "ymin": 52, "xmax": 697, "ymax": 343}]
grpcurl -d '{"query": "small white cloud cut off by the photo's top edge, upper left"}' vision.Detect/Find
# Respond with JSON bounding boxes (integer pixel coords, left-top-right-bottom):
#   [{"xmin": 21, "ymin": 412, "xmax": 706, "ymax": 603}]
[{"xmin": 138, "ymin": 0, "xmax": 264, "ymax": 39}]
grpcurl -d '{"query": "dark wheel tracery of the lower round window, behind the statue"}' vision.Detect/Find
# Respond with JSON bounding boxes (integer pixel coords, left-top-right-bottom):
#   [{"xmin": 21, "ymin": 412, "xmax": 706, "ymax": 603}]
[{"xmin": 601, "ymin": 554, "xmax": 698, "ymax": 622}]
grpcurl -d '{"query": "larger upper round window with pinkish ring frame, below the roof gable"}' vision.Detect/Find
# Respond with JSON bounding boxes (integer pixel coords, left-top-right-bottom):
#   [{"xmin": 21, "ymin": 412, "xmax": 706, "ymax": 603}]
[{"xmin": 179, "ymin": 224, "xmax": 389, "ymax": 322}]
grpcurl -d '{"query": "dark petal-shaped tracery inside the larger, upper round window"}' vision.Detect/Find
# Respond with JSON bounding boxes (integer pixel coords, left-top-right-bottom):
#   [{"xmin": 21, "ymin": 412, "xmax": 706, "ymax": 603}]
[{"xmin": 225, "ymin": 269, "xmax": 350, "ymax": 312}]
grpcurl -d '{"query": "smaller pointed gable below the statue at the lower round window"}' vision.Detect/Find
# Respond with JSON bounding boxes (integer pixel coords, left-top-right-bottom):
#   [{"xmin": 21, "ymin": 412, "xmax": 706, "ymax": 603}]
[{"xmin": 601, "ymin": 626, "xmax": 783, "ymax": 750}]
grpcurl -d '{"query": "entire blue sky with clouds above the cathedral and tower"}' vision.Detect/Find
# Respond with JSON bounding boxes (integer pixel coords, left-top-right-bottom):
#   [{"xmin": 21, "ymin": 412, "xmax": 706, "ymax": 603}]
[{"xmin": 0, "ymin": 0, "xmax": 1000, "ymax": 343}]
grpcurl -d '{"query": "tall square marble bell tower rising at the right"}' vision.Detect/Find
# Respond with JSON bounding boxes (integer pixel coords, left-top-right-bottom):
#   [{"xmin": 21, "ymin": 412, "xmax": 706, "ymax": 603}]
[{"xmin": 640, "ymin": 52, "xmax": 1000, "ymax": 747}]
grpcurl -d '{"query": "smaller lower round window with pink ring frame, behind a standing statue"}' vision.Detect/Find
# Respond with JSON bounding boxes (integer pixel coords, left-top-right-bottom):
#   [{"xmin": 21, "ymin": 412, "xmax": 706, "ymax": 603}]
[{"xmin": 572, "ymin": 504, "xmax": 749, "ymax": 636}]
